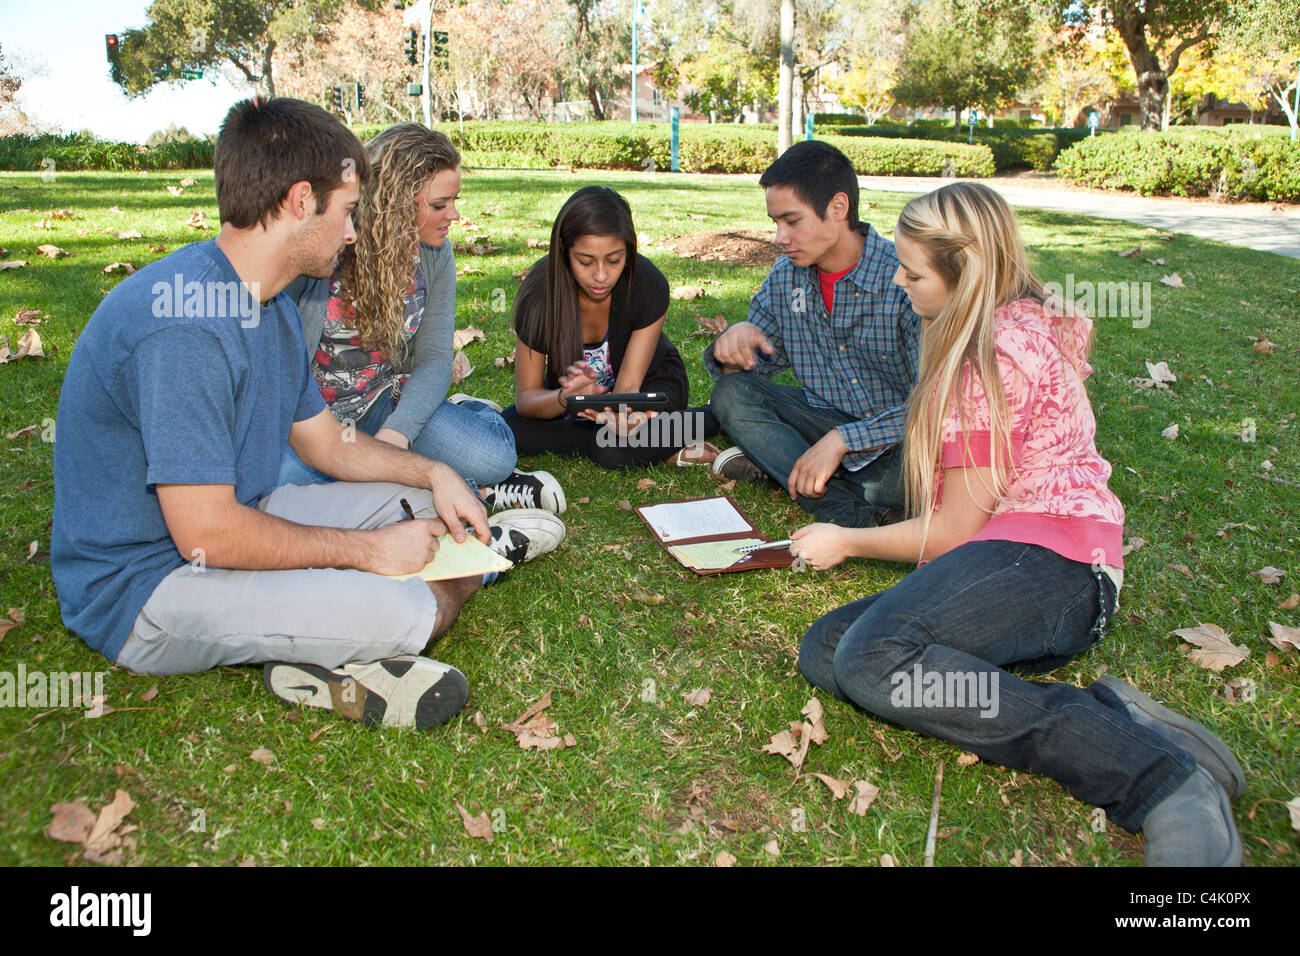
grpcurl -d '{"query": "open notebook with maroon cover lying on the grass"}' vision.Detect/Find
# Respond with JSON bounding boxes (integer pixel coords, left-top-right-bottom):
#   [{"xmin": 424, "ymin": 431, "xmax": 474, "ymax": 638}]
[{"xmin": 637, "ymin": 494, "xmax": 793, "ymax": 575}]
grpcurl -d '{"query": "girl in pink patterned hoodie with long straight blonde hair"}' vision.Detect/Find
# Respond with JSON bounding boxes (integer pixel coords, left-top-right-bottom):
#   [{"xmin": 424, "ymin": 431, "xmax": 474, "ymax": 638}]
[{"xmin": 790, "ymin": 182, "xmax": 1244, "ymax": 866}]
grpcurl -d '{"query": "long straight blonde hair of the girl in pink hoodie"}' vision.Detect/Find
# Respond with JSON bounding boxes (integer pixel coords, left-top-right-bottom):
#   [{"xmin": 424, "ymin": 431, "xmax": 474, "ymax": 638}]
[{"xmin": 897, "ymin": 182, "xmax": 1091, "ymax": 553}]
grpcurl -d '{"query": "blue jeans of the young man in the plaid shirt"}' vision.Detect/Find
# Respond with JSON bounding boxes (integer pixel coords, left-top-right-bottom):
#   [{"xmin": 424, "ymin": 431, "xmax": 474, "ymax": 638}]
[{"xmin": 709, "ymin": 372, "xmax": 904, "ymax": 528}]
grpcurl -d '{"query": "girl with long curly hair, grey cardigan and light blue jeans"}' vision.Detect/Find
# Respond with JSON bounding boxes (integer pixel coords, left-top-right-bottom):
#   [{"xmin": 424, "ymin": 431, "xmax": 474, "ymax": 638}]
[{"xmin": 281, "ymin": 122, "xmax": 564, "ymax": 512}]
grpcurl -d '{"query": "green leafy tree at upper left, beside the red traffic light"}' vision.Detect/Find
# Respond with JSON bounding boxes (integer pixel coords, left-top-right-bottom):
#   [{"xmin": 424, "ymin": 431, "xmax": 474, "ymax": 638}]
[{"xmin": 113, "ymin": 0, "xmax": 356, "ymax": 98}]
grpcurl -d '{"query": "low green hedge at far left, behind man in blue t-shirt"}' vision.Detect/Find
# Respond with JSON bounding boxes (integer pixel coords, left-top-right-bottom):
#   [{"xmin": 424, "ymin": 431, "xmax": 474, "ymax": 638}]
[{"xmin": 0, "ymin": 133, "xmax": 213, "ymax": 172}]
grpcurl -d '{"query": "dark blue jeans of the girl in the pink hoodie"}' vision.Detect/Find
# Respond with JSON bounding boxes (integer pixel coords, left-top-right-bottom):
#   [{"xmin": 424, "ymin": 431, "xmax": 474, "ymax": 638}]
[{"xmin": 800, "ymin": 541, "xmax": 1196, "ymax": 832}]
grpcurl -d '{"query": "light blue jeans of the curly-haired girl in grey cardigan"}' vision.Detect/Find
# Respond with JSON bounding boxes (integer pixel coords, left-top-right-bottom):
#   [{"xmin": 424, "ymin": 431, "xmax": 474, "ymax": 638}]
[{"xmin": 276, "ymin": 392, "xmax": 515, "ymax": 488}]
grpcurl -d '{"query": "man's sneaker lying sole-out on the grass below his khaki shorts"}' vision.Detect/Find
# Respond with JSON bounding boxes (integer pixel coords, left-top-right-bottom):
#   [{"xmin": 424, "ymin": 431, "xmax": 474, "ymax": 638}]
[{"xmin": 261, "ymin": 656, "xmax": 469, "ymax": 730}]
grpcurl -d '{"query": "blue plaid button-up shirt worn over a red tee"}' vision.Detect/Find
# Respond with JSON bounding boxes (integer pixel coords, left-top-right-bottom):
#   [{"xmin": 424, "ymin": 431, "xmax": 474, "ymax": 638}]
[{"xmin": 705, "ymin": 222, "xmax": 920, "ymax": 471}]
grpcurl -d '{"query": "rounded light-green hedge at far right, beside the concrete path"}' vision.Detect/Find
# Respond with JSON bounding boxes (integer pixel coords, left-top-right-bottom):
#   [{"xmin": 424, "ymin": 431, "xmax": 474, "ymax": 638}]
[{"xmin": 1056, "ymin": 127, "xmax": 1300, "ymax": 203}]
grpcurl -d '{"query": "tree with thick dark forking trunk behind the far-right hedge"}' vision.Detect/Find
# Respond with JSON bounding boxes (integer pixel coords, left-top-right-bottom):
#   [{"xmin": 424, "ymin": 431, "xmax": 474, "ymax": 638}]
[{"xmin": 1054, "ymin": 0, "xmax": 1227, "ymax": 130}]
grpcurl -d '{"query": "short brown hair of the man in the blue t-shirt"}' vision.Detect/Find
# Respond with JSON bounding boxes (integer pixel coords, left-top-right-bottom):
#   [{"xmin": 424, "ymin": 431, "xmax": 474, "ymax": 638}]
[{"xmin": 213, "ymin": 96, "xmax": 371, "ymax": 229}]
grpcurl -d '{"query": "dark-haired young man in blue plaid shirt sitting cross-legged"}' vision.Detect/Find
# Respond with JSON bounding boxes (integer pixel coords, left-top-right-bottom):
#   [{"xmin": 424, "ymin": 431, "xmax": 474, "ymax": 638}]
[{"xmin": 705, "ymin": 140, "xmax": 920, "ymax": 527}]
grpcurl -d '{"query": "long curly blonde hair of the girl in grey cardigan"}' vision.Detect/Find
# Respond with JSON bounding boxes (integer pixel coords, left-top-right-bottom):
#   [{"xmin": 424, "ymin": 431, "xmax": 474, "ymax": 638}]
[{"xmin": 341, "ymin": 122, "xmax": 460, "ymax": 360}]
